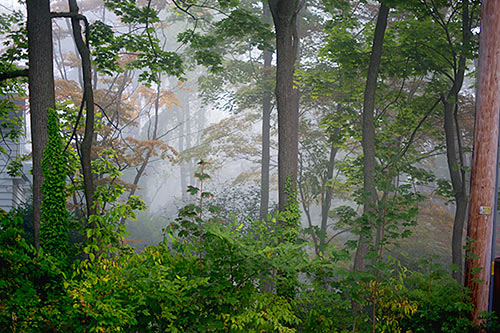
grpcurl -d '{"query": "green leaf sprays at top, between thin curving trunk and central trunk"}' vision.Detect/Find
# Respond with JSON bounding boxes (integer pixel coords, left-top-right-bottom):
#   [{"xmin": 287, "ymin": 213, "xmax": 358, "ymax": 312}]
[{"xmin": 90, "ymin": 0, "xmax": 273, "ymax": 80}]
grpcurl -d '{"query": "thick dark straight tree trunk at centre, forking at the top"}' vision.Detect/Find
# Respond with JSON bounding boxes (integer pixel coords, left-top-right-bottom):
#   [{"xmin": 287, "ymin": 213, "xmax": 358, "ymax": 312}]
[{"xmin": 269, "ymin": 0, "xmax": 299, "ymax": 211}]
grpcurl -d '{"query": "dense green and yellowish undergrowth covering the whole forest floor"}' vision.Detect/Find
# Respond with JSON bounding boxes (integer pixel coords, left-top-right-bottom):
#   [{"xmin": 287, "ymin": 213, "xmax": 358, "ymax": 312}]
[{"xmin": 0, "ymin": 205, "xmax": 494, "ymax": 332}]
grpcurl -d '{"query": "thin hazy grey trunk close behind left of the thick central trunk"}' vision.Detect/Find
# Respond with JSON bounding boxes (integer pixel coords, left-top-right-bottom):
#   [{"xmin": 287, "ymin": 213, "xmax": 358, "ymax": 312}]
[{"xmin": 259, "ymin": 4, "xmax": 273, "ymax": 220}]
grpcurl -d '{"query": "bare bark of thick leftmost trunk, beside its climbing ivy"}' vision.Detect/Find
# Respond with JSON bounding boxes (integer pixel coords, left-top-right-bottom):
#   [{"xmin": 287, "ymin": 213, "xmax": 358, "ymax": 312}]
[{"xmin": 26, "ymin": 0, "xmax": 55, "ymax": 251}]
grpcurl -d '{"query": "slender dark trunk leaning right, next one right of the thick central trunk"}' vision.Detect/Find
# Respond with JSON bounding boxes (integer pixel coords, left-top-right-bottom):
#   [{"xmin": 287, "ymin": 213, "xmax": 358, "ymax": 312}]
[{"xmin": 354, "ymin": 3, "xmax": 389, "ymax": 271}]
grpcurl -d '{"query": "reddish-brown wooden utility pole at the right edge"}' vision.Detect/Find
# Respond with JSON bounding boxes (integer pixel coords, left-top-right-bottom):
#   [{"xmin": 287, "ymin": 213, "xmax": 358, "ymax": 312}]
[{"xmin": 465, "ymin": 0, "xmax": 500, "ymax": 324}]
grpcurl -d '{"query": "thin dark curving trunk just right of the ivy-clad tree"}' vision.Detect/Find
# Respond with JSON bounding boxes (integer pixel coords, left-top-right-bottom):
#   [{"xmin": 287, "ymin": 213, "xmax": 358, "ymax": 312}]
[{"xmin": 68, "ymin": 0, "xmax": 97, "ymax": 217}]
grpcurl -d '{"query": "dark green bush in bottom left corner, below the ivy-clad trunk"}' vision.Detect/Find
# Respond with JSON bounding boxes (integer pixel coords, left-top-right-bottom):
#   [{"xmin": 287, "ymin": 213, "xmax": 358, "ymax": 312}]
[{"xmin": 0, "ymin": 210, "xmax": 71, "ymax": 332}]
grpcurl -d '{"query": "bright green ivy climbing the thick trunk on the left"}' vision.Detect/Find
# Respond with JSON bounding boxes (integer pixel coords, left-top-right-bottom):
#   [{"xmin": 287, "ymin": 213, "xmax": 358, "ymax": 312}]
[{"xmin": 40, "ymin": 109, "xmax": 69, "ymax": 258}]
